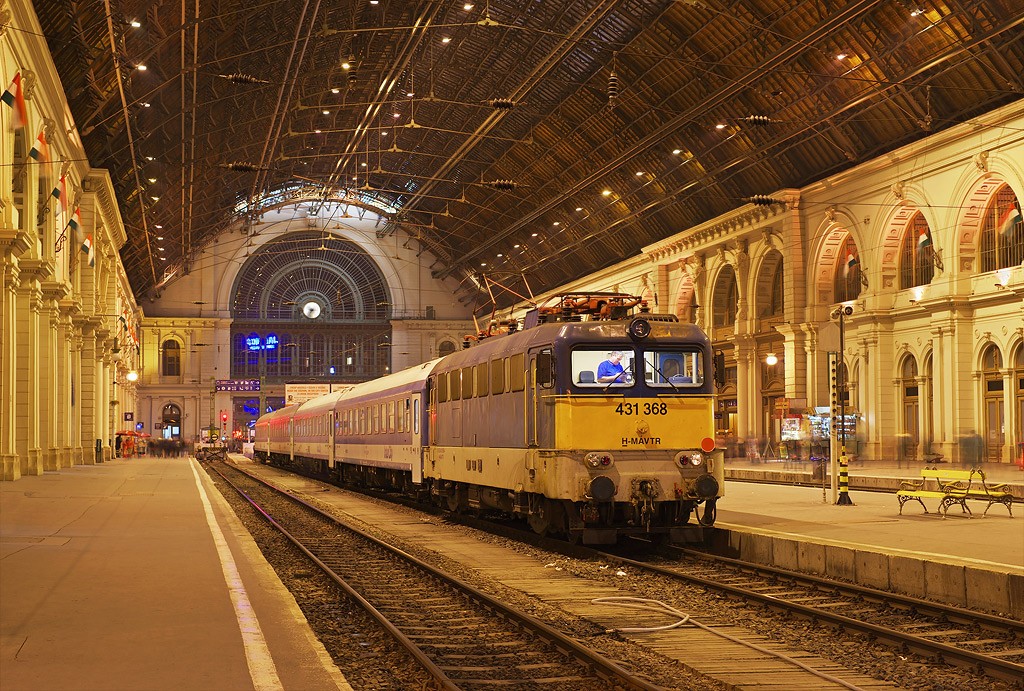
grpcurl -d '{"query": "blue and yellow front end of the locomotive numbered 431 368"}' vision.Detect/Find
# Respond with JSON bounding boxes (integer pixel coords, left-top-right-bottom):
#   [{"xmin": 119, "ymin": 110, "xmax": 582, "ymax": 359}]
[{"xmin": 541, "ymin": 317, "xmax": 724, "ymax": 542}]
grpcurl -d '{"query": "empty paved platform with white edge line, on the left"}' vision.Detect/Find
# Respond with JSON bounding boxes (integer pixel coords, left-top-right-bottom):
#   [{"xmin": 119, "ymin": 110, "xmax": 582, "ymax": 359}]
[{"xmin": 0, "ymin": 458, "xmax": 350, "ymax": 691}]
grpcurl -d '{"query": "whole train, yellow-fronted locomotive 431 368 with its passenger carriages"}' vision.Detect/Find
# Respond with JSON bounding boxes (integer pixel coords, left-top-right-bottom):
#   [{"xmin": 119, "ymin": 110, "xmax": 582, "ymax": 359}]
[{"xmin": 255, "ymin": 293, "xmax": 724, "ymax": 544}]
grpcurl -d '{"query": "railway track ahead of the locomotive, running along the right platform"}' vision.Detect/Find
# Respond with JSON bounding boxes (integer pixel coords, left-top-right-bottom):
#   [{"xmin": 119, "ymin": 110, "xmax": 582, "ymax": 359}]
[{"xmin": 598, "ymin": 546, "xmax": 1024, "ymax": 686}]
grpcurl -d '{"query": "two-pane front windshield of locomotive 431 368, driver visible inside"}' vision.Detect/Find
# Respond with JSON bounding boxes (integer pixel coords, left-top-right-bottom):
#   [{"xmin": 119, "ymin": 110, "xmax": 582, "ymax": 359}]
[{"xmin": 571, "ymin": 346, "xmax": 705, "ymax": 390}]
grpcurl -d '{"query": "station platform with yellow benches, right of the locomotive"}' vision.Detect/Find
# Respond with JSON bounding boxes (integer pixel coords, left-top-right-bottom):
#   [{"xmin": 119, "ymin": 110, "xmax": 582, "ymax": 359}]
[{"xmin": 715, "ymin": 459, "xmax": 1024, "ymax": 620}]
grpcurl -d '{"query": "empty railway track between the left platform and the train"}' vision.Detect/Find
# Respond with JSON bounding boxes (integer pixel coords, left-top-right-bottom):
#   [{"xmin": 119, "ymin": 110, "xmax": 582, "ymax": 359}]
[{"xmin": 207, "ymin": 463, "xmax": 659, "ymax": 691}]
